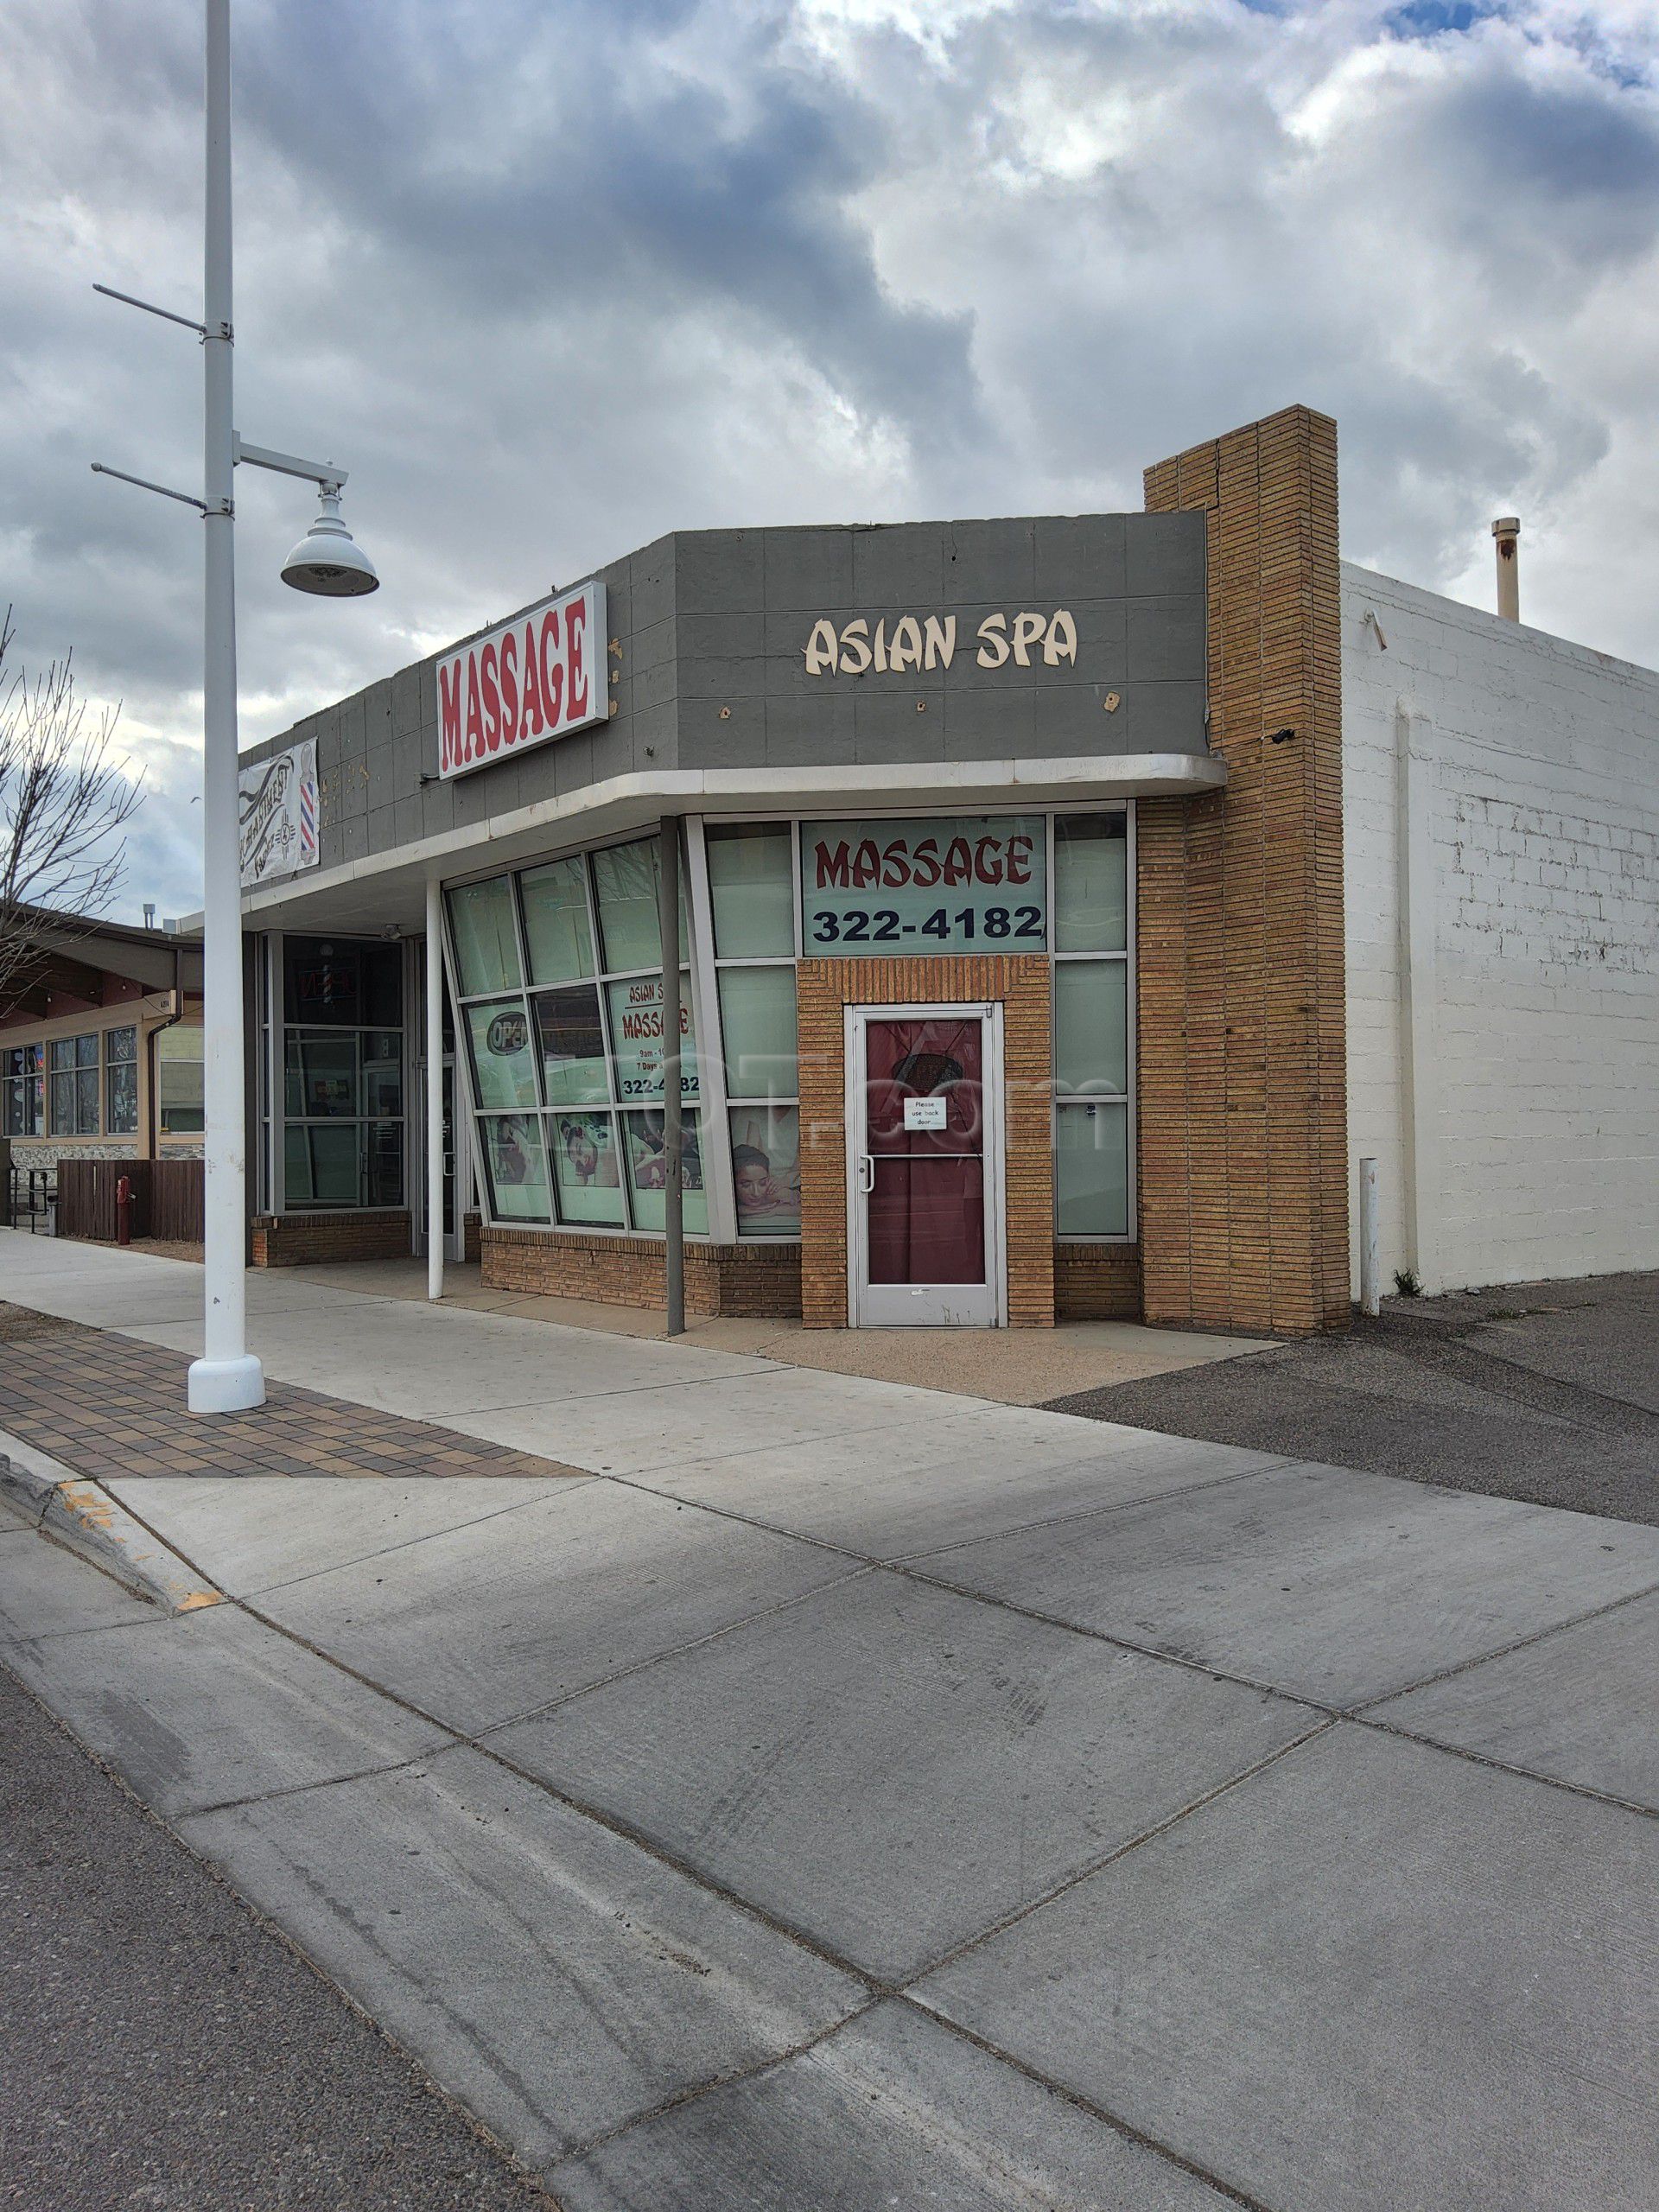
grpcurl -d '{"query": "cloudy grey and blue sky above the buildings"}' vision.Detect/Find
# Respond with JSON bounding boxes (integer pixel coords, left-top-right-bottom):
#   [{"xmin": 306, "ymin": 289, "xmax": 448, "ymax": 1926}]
[{"xmin": 0, "ymin": 0, "xmax": 1659, "ymax": 916}]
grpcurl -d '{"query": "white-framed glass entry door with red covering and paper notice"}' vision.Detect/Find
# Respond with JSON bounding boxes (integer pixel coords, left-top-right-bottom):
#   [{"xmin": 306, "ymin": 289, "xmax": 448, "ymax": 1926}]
[{"xmin": 847, "ymin": 1007, "xmax": 1007, "ymax": 1330}]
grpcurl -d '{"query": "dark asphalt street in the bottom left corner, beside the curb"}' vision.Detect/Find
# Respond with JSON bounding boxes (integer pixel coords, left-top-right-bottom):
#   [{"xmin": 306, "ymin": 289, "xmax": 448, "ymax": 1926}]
[{"xmin": 0, "ymin": 1668, "xmax": 550, "ymax": 2212}]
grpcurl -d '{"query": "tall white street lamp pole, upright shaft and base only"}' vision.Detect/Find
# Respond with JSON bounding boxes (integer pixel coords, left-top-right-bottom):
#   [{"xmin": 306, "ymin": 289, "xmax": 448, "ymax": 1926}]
[{"xmin": 188, "ymin": 0, "xmax": 263, "ymax": 1414}]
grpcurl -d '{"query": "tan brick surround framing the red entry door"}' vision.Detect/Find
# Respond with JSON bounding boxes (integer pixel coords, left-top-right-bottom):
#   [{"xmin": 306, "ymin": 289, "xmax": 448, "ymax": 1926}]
[{"xmin": 797, "ymin": 953, "xmax": 1055, "ymax": 1330}]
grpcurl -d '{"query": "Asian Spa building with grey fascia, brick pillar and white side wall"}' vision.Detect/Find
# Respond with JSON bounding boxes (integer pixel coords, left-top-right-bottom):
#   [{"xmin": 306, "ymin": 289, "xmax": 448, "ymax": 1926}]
[{"xmin": 224, "ymin": 407, "xmax": 1659, "ymax": 1332}]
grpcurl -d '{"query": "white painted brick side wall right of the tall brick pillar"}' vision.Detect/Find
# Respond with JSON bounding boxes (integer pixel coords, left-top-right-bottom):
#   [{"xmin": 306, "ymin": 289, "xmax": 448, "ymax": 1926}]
[{"xmin": 1343, "ymin": 564, "xmax": 1659, "ymax": 1289}]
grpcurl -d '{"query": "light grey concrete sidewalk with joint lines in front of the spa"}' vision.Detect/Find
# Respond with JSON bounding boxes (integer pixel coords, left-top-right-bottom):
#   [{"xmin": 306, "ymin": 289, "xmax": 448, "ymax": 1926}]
[{"xmin": 0, "ymin": 1241, "xmax": 1659, "ymax": 2212}]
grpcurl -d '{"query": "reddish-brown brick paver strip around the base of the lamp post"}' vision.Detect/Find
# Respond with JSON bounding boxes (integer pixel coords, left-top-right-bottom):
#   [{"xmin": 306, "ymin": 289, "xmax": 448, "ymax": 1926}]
[{"xmin": 0, "ymin": 1305, "xmax": 580, "ymax": 1482}]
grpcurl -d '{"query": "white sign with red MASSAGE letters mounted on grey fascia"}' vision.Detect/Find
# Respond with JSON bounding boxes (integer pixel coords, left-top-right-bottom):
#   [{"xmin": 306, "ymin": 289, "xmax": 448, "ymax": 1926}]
[{"xmin": 438, "ymin": 584, "xmax": 611, "ymax": 777}]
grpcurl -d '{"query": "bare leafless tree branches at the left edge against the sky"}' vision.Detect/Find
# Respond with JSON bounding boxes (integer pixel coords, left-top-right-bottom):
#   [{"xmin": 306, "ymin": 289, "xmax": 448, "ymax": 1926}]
[{"xmin": 0, "ymin": 608, "xmax": 143, "ymax": 1004}]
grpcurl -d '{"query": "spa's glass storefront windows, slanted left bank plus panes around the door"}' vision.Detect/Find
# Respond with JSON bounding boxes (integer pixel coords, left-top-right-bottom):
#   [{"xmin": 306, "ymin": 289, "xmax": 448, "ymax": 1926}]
[{"xmin": 449, "ymin": 807, "xmax": 1135, "ymax": 1239}]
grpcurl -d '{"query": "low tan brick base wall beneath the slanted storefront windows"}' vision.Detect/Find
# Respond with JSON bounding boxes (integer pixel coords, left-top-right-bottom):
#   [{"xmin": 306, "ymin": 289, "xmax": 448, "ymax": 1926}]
[{"xmin": 478, "ymin": 1228, "xmax": 801, "ymax": 1320}]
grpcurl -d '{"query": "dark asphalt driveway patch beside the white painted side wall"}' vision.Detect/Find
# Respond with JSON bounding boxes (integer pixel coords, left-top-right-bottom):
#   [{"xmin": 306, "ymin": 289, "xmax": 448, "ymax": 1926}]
[{"xmin": 1051, "ymin": 1274, "xmax": 1659, "ymax": 1522}]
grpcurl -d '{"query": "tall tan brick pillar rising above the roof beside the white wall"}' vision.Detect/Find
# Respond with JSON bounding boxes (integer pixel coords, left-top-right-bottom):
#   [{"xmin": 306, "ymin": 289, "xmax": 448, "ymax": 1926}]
[{"xmin": 1137, "ymin": 407, "xmax": 1350, "ymax": 1334}]
